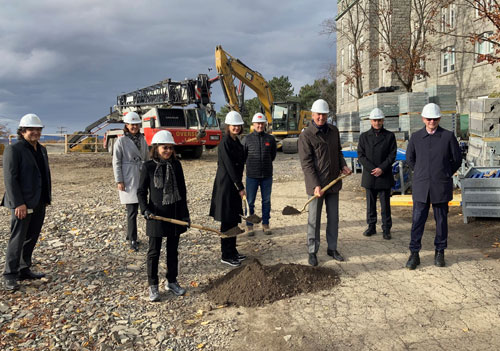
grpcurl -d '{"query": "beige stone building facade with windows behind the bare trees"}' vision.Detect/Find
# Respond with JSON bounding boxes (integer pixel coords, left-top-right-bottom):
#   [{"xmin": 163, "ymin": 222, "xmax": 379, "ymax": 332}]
[{"xmin": 336, "ymin": 0, "xmax": 500, "ymax": 114}]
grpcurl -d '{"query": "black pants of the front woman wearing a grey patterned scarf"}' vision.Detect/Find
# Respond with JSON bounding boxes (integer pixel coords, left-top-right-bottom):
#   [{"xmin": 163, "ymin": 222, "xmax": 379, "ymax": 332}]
[{"xmin": 147, "ymin": 234, "xmax": 180, "ymax": 285}]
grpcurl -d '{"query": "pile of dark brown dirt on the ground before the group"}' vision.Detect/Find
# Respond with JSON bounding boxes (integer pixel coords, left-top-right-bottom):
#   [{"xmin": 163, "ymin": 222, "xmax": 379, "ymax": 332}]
[{"xmin": 205, "ymin": 259, "xmax": 340, "ymax": 307}]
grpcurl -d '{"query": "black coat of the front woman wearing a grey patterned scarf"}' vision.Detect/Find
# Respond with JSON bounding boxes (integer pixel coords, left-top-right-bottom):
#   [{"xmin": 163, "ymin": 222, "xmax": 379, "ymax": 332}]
[{"xmin": 137, "ymin": 160, "xmax": 189, "ymax": 237}]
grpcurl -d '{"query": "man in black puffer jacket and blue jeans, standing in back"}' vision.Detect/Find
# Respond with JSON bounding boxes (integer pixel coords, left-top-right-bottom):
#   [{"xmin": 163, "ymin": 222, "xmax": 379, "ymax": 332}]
[{"xmin": 243, "ymin": 112, "xmax": 276, "ymax": 236}]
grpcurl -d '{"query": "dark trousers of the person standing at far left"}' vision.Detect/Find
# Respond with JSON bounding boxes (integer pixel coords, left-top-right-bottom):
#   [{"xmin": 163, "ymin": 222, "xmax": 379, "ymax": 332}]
[{"xmin": 3, "ymin": 203, "xmax": 45, "ymax": 278}]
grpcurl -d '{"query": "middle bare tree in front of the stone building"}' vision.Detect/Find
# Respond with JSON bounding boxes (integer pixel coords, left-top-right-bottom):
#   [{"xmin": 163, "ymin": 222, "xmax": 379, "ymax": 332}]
[{"xmin": 365, "ymin": 0, "xmax": 449, "ymax": 91}]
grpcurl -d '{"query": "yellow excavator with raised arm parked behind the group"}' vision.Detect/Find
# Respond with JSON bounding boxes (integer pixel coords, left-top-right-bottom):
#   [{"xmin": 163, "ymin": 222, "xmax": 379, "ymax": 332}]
[{"xmin": 215, "ymin": 45, "xmax": 311, "ymax": 153}]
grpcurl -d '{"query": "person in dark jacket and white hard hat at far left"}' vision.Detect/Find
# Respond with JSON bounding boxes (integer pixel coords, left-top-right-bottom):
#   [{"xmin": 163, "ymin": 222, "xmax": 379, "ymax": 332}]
[{"xmin": 1, "ymin": 113, "xmax": 52, "ymax": 290}]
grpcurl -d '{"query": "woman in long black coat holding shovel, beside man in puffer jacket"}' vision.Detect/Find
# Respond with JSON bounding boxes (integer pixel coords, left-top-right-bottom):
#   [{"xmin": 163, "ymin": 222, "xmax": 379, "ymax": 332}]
[{"xmin": 209, "ymin": 111, "xmax": 246, "ymax": 267}]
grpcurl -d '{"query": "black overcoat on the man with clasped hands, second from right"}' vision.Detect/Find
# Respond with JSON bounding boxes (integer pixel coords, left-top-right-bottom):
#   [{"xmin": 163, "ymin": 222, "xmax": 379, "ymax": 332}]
[{"xmin": 358, "ymin": 128, "xmax": 398, "ymax": 189}]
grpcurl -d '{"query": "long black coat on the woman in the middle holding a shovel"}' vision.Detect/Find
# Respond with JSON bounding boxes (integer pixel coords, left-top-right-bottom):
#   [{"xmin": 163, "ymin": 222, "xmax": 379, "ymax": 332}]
[{"xmin": 210, "ymin": 134, "xmax": 245, "ymax": 223}]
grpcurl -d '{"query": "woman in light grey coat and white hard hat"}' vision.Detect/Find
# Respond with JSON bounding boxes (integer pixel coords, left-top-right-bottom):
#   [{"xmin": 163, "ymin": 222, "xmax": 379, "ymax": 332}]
[{"xmin": 113, "ymin": 112, "xmax": 149, "ymax": 251}]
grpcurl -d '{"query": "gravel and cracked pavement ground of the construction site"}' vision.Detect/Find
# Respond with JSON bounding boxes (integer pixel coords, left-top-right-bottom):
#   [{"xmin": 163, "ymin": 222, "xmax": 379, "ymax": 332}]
[{"xmin": 0, "ymin": 150, "xmax": 500, "ymax": 351}]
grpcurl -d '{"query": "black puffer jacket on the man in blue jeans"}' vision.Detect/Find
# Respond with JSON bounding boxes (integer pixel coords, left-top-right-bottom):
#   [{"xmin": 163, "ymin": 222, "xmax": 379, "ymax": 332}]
[{"xmin": 243, "ymin": 131, "xmax": 276, "ymax": 178}]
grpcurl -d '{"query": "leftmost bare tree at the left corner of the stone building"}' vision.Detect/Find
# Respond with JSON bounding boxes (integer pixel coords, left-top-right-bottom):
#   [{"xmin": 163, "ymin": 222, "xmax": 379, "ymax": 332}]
[{"xmin": 322, "ymin": 1, "xmax": 368, "ymax": 99}]
